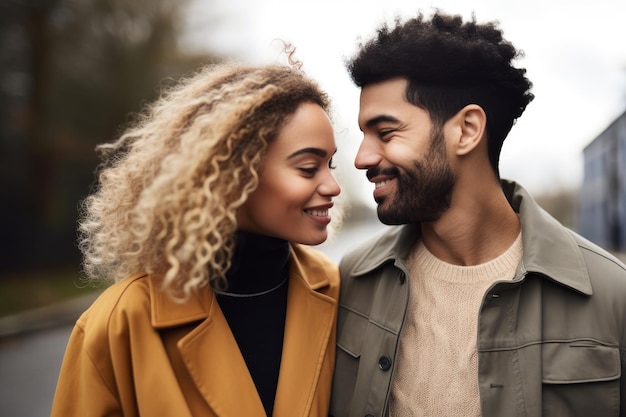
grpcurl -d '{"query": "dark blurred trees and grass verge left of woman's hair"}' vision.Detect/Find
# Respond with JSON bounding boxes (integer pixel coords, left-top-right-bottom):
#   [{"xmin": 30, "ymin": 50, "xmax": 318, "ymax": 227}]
[{"xmin": 0, "ymin": 0, "xmax": 216, "ymax": 312}]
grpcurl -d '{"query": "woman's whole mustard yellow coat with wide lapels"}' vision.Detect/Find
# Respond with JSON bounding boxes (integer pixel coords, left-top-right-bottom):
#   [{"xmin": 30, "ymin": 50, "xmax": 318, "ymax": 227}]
[{"xmin": 51, "ymin": 245, "xmax": 339, "ymax": 417}]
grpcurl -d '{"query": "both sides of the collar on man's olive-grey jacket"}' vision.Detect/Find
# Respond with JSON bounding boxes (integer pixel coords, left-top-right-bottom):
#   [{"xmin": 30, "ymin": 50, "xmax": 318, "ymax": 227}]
[{"xmin": 346, "ymin": 180, "xmax": 593, "ymax": 295}]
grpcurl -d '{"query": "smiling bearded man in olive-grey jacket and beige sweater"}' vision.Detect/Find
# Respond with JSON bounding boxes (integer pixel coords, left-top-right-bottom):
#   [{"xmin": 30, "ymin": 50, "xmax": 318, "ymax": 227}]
[{"xmin": 331, "ymin": 9, "xmax": 626, "ymax": 417}]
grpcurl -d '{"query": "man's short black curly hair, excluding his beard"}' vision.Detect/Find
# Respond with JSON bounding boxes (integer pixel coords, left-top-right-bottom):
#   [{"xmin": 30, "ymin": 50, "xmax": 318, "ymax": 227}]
[{"xmin": 346, "ymin": 11, "xmax": 534, "ymax": 176}]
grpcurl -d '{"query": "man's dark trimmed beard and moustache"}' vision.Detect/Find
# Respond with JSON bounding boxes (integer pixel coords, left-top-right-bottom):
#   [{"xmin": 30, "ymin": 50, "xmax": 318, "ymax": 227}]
[{"xmin": 368, "ymin": 129, "xmax": 455, "ymax": 225}]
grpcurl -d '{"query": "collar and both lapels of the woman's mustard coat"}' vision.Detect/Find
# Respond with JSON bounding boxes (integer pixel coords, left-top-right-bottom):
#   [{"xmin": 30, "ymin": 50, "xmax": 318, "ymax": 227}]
[{"xmin": 150, "ymin": 245, "xmax": 338, "ymax": 417}]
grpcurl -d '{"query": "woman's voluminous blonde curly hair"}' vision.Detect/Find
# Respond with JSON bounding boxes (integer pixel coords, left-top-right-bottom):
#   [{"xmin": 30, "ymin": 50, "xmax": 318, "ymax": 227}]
[{"xmin": 79, "ymin": 62, "xmax": 330, "ymax": 300}]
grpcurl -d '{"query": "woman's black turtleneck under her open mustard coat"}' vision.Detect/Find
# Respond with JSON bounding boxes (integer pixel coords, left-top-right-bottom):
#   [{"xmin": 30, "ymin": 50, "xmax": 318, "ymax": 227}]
[{"xmin": 216, "ymin": 231, "xmax": 290, "ymax": 416}]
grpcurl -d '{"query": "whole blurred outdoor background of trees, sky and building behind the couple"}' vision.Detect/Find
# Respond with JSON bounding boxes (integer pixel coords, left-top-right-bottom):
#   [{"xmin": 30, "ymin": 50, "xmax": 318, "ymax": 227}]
[{"xmin": 0, "ymin": 0, "xmax": 626, "ymax": 416}]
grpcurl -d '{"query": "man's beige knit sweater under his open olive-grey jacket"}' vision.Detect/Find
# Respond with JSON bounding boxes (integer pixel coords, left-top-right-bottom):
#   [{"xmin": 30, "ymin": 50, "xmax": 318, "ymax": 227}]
[{"xmin": 389, "ymin": 233, "xmax": 522, "ymax": 417}]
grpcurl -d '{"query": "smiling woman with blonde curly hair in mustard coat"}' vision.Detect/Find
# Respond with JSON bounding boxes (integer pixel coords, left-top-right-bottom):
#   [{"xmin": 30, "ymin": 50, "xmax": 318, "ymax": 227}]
[{"xmin": 52, "ymin": 59, "xmax": 340, "ymax": 417}]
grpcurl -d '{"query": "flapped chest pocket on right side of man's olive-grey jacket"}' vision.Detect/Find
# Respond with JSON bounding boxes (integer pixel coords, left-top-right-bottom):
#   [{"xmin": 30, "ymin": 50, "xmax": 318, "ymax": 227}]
[{"xmin": 542, "ymin": 341, "xmax": 621, "ymax": 417}]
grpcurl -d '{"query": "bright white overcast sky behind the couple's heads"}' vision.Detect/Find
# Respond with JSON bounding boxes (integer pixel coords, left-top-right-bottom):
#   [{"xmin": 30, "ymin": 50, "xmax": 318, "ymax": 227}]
[{"xmin": 180, "ymin": 0, "xmax": 626, "ymax": 202}]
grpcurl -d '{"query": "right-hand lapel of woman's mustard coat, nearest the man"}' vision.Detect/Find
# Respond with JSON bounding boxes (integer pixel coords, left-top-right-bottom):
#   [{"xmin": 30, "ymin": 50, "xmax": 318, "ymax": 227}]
[{"xmin": 273, "ymin": 245, "xmax": 337, "ymax": 417}]
